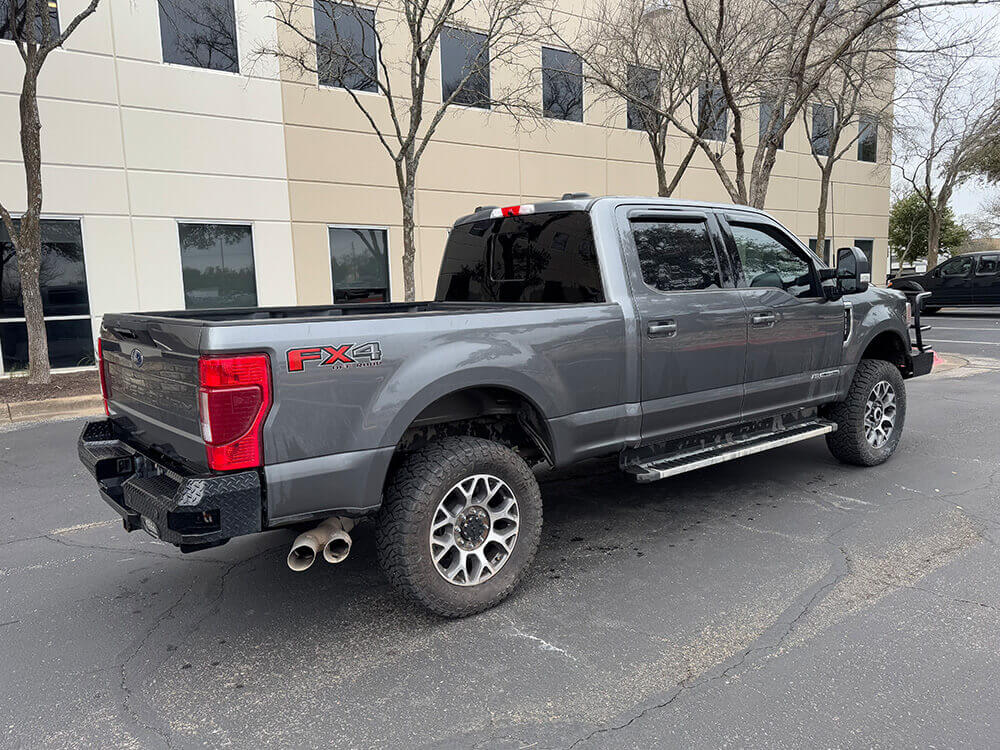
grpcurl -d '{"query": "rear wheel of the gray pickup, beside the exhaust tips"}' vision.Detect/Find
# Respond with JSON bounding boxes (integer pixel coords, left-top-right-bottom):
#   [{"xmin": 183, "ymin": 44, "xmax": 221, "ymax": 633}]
[{"xmin": 377, "ymin": 437, "xmax": 542, "ymax": 617}]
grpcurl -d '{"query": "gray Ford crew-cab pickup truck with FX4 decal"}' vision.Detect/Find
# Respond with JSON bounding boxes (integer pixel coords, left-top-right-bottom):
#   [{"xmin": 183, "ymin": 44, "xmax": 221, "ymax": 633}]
[{"xmin": 79, "ymin": 194, "xmax": 933, "ymax": 617}]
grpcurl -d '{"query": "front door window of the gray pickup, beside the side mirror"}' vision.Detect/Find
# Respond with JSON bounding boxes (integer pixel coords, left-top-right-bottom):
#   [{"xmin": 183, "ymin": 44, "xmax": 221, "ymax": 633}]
[{"xmin": 732, "ymin": 224, "xmax": 815, "ymax": 297}]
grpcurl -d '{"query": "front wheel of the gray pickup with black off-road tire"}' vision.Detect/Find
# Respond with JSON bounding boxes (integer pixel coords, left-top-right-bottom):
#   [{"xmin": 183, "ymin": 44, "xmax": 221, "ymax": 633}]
[{"xmin": 826, "ymin": 359, "xmax": 906, "ymax": 466}]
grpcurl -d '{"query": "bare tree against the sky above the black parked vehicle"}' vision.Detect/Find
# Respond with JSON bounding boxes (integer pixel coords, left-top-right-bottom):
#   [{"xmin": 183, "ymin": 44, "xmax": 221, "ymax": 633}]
[{"xmin": 894, "ymin": 51, "xmax": 1000, "ymax": 268}]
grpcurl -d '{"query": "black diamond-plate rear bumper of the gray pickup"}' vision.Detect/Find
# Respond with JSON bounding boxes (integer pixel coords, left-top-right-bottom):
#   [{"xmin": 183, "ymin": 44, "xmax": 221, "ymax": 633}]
[{"xmin": 77, "ymin": 419, "xmax": 263, "ymax": 552}]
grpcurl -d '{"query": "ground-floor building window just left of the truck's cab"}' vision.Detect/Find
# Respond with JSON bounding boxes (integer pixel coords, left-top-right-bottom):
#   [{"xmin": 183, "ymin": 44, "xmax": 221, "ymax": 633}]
[{"xmin": 330, "ymin": 227, "xmax": 389, "ymax": 305}]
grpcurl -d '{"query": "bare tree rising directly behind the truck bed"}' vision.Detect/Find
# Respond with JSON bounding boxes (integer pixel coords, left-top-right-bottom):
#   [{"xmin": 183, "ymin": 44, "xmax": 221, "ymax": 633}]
[{"xmin": 257, "ymin": 0, "xmax": 538, "ymax": 301}]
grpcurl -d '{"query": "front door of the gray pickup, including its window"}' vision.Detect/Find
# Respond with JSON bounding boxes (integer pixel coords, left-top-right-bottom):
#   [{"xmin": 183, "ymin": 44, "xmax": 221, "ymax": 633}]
[{"xmin": 721, "ymin": 212, "xmax": 845, "ymax": 419}]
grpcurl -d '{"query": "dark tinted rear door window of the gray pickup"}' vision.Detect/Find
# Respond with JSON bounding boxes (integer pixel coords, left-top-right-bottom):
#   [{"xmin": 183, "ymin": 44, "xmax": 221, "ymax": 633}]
[{"xmin": 632, "ymin": 220, "xmax": 721, "ymax": 292}]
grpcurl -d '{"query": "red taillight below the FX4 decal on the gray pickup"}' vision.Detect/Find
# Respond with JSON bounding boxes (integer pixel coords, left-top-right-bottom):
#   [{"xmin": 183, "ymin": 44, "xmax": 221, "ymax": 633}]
[{"xmin": 198, "ymin": 354, "xmax": 271, "ymax": 471}]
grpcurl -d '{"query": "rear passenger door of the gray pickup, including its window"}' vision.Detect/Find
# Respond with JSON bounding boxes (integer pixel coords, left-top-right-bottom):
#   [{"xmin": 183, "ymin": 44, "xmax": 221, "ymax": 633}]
[{"xmin": 619, "ymin": 207, "xmax": 747, "ymax": 443}]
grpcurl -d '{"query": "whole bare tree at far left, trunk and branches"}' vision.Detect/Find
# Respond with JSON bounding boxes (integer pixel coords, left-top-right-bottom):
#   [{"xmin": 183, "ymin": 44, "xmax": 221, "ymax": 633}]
[{"xmin": 0, "ymin": 0, "xmax": 98, "ymax": 384}]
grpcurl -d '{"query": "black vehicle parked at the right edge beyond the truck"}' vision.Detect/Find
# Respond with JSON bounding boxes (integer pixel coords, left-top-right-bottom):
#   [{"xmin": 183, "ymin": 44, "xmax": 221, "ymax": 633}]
[{"xmin": 888, "ymin": 251, "xmax": 1000, "ymax": 314}]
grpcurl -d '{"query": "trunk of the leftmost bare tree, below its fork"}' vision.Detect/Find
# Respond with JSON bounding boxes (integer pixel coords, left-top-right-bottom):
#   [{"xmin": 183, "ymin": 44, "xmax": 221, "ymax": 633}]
[{"xmin": 12, "ymin": 70, "xmax": 52, "ymax": 384}]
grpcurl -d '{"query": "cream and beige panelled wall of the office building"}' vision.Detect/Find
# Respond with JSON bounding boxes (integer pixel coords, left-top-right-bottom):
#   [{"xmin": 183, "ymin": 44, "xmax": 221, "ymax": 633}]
[{"xmin": 0, "ymin": 0, "xmax": 889, "ymax": 372}]
